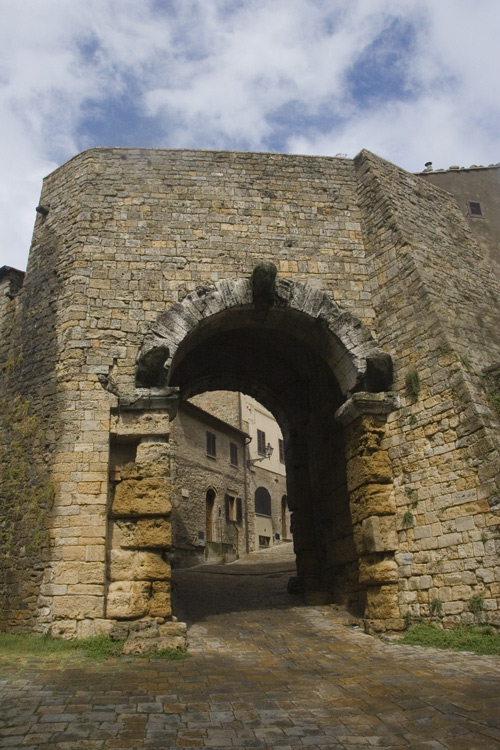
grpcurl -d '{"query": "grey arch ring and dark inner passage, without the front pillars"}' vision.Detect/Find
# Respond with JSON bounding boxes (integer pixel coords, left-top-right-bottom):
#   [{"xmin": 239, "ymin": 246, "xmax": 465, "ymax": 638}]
[{"xmin": 138, "ymin": 282, "xmax": 392, "ymax": 613}]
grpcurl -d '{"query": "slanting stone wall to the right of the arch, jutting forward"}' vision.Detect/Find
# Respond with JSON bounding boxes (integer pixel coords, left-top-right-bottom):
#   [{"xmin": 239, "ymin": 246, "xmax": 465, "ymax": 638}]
[{"xmin": 356, "ymin": 154, "xmax": 500, "ymax": 625}]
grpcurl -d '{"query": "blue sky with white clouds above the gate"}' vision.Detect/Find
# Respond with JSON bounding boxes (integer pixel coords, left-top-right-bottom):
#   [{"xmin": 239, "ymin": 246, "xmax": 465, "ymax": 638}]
[{"xmin": 0, "ymin": 0, "xmax": 500, "ymax": 269}]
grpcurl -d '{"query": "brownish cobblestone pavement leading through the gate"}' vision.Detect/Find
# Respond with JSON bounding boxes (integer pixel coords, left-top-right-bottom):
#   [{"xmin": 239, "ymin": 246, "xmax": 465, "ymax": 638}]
[{"xmin": 0, "ymin": 551, "xmax": 500, "ymax": 750}]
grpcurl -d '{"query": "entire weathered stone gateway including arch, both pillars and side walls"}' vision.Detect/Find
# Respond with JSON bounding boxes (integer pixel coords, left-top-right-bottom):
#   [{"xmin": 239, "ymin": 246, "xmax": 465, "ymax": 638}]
[{"xmin": 0, "ymin": 149, "xmax": 500, "ymax": 636}]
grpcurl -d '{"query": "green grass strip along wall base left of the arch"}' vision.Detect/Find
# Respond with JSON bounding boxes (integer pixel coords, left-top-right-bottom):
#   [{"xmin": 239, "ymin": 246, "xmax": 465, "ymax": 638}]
[{"xmin": 0, "ymin": 633, "xmax": 188, "ymax": 660}]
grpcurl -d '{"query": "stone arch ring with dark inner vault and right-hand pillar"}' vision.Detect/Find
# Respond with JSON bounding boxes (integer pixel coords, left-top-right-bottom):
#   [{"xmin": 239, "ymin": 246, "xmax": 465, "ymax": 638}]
[{"xmin": 132, "ymin": 263, "xmax": 399, "ymax": 629}]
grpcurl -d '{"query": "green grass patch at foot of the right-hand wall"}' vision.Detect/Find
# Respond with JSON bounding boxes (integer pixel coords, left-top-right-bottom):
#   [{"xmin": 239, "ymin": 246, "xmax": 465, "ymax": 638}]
[{"xmin": 399, "ymin": 624, "xmax": 500, "ymax": 655}]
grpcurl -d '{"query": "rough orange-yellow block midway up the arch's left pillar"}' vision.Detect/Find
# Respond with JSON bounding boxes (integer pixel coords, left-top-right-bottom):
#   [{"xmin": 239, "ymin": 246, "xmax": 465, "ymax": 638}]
[{"xmin": 111, "ymin": 477, "xmax": 172, "ymax": 516}]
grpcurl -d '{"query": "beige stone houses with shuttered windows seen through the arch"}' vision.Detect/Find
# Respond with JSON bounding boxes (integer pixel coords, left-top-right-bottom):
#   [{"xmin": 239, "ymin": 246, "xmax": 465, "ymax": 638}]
[{"xmin": 170, "ymin": 391, "xmax": 291, "ymax": 567}]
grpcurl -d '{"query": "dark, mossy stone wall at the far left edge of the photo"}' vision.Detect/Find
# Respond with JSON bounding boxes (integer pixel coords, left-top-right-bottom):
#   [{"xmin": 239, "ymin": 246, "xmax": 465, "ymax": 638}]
[{"xmin": 0, "ymin": 267, "xmax": 53, "ymax": 630}]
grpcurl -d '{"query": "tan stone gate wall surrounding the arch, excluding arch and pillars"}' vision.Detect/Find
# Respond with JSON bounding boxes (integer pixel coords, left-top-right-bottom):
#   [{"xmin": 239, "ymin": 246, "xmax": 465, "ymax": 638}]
[{"xmin": 2, "ymin": 149, "xmax": 500, "ymax": 635}]
